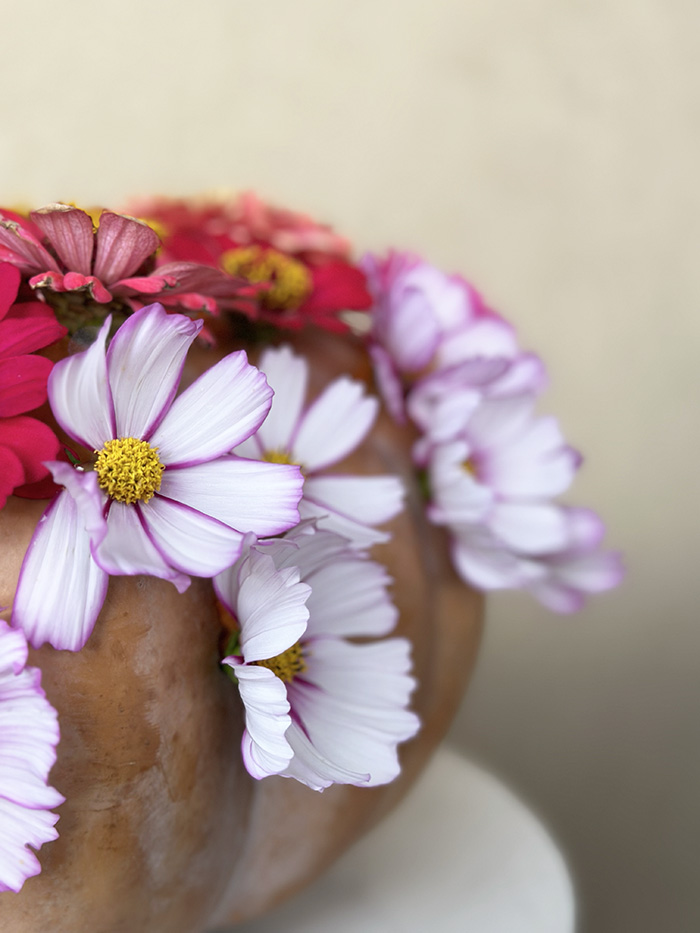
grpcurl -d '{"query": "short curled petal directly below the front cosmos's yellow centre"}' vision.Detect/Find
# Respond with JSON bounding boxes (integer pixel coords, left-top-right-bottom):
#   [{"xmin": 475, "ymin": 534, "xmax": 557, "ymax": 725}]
[{"xmin": 92, "ymin": 501, "xmax": 191, "ymax": 593}]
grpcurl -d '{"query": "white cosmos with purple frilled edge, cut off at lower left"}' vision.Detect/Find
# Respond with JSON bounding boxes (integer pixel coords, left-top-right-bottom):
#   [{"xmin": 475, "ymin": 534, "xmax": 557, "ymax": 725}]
[{"xmin": 0, "ymin": 620, "xmax": 64, "ymax": 891}]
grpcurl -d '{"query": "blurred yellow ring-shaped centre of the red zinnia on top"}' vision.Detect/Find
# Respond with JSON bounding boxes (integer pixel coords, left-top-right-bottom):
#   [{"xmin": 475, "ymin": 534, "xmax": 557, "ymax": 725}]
[{"xmin": 221, "ymin": 246, "xmax": 311, "ymax": 311}]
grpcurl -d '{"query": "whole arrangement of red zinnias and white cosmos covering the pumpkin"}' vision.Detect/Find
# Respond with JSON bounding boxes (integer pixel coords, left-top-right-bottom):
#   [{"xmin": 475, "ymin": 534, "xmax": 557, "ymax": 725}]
[{"xmin": 0, "ymin": 194, "xmax": 622, "ymax": 892}]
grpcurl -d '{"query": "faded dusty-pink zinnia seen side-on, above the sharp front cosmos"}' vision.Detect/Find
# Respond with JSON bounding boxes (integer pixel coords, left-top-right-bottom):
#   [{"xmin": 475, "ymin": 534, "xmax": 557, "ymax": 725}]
[{"xmin": 0, "ymin": 204, "xmax": 251, "ymax": 311}]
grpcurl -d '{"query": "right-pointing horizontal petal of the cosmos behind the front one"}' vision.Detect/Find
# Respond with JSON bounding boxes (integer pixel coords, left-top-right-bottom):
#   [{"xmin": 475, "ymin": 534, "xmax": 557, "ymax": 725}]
[{"xmin": 304, "ymin": 476, "xmax": 406, "ymax": 525}]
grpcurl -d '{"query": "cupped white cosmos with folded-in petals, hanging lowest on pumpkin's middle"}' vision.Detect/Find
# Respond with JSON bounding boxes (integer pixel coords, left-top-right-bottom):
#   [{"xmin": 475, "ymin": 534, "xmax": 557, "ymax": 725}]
[{"xmin": 214, "ymin": 525, "xmax": 419, "ymax": 790}]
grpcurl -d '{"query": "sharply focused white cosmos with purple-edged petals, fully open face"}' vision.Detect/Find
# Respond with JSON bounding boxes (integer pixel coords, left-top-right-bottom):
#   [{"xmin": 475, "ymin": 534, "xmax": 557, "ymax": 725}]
[{"xmin": 13, "ymin": 305, "xmax": 303, "ymax": 651}]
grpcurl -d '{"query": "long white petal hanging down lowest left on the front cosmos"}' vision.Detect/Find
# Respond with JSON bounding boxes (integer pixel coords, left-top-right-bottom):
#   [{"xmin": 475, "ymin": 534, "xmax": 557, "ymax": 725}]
[{"xmin": 12, "ymin": 490, "xmax": 108, "ymax": 651}]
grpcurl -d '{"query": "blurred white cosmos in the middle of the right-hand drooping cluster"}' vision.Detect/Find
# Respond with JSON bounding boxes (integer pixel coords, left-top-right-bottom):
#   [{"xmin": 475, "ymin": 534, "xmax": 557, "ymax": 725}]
[{"xmin": 427, "ymin": 395, "xmax": 580, "ymax": 589}]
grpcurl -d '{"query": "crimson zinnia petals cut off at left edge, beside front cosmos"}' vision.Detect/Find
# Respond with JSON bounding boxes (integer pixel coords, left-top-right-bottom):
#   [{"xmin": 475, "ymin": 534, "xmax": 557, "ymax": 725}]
[{"xmin": 0, "ymin": 263, "xmax": 66, "ymax": 508}]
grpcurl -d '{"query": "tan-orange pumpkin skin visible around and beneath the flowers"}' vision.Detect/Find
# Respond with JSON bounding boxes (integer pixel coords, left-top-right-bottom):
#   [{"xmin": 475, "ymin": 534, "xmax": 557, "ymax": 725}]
[{"xmin": 0, "ymin": 324, "xmax": 483, "ymax": 933}]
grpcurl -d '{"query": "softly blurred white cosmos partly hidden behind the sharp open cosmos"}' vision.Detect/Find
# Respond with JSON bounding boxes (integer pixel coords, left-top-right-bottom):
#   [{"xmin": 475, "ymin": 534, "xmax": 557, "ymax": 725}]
[{"xmin": 235, "ymin": 347, "xmax": 404, "ymax": 547}]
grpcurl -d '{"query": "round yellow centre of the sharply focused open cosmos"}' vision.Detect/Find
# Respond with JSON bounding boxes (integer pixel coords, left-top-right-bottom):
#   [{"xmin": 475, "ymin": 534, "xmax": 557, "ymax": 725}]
[{"xmin": 95, "ymin": 437, "xmax": 165, "ymax": 505}]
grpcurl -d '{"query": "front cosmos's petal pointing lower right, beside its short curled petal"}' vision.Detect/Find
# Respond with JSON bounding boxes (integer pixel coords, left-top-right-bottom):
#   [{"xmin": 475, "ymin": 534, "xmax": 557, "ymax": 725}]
[{"xmin": 139, "ymin": 496, "xmax": 243, "ymax": 577}]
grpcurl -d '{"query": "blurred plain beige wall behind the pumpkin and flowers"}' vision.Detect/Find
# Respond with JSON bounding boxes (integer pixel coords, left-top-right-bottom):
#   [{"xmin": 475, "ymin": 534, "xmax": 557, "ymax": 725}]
[{"xmin": 0, "ymin": 0, "xmax": 700, "ymax": 933}]
